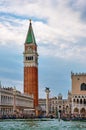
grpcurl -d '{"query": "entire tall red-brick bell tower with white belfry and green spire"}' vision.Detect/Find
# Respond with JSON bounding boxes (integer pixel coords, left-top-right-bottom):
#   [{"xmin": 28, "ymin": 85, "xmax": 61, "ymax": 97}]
[{"xmin": 24, "ymin": 20, "xmax": 38, "ymax": 108}]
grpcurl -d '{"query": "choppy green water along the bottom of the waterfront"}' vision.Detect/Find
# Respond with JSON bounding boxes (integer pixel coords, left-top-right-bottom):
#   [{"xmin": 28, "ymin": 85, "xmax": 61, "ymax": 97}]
[{"xmin": 0, "ymin": 119, "xmax": 86, "ymax": 130}]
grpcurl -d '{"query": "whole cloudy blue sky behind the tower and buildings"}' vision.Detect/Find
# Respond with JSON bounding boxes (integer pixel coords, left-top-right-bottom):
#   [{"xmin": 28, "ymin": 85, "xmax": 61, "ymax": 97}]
[{"xmin": 0, "ymin": 0, "xmax": 86, "ymax": 98}]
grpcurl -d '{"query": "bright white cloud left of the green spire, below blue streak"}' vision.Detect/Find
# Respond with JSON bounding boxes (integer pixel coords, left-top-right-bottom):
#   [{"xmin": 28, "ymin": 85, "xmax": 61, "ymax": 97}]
[{"xmin": 0, "ymin": 17, "xmax": 25, "ymax": 44}]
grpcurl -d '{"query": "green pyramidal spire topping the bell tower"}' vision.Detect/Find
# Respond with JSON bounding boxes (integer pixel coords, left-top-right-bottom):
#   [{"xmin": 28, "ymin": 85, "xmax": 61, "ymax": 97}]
[{"xmin": 25, "ymin": 20, "xmax": 36, "ymax": 44}]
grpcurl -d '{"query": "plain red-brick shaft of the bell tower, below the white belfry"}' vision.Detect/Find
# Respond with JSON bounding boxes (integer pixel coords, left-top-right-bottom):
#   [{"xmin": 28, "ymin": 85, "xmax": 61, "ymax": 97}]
[{"xmin": 24, "ymin": 67, "xmax": 38, "ymax": 107}]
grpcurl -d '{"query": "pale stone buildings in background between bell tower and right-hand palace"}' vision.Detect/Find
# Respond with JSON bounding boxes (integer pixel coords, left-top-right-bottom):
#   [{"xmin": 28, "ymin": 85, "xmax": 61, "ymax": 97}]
[{"xmin": 39, "ymin": 95, "xmax": 71, "ymax": 116}]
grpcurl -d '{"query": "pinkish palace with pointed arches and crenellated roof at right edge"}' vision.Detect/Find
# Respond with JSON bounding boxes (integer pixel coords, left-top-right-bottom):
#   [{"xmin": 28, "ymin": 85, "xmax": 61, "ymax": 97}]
[{"xmin": 71, "ymin": 73, "xmax": 86, "ymax": 116}]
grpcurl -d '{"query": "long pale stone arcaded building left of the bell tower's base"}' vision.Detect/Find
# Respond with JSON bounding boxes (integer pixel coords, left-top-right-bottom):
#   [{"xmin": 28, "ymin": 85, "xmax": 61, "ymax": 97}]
[{"xmin": 0, "ymin": 88, "xmax": 33, "ymax": 115}]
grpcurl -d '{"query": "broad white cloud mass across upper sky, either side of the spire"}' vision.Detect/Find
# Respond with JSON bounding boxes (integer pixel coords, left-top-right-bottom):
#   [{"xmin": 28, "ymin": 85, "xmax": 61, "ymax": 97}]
[{"xmin": 0, "ymin": 0, "xmax": 86, "ymax": 59}]
